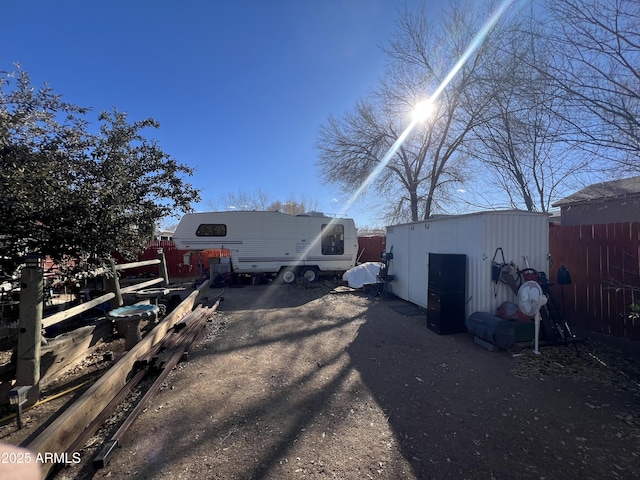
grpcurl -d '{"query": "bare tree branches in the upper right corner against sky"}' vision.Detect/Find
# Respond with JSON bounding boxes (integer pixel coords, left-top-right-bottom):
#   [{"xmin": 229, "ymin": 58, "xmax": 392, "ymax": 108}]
[{"xmin": 547, "ymin": 0, "xmax": 640, "ymax": 172}]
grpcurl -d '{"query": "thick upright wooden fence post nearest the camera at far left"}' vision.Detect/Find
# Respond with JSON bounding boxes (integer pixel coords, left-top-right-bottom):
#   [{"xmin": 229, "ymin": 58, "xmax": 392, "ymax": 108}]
[{"xmin": 16, "ymin": 256, "xmax": 44, "ymax": 406}]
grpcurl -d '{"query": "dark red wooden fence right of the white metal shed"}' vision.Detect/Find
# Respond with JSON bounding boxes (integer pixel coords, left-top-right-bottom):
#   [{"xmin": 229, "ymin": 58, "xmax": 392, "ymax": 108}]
[{"xmin": 549, "ymin": 222, "xmax": 640, "ymax": 340}]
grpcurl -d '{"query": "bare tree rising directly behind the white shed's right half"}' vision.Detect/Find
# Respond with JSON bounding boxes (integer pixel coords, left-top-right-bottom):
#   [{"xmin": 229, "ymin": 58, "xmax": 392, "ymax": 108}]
[{"xmin": 466, "ymin": 8, "xmax": 597, "ymax": 212}]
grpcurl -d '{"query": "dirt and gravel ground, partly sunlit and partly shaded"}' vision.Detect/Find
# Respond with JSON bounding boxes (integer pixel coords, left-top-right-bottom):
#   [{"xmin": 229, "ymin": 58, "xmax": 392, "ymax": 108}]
[{"xmin": 6, "ymin": 282, "xmax": 640, "ymax": 480}]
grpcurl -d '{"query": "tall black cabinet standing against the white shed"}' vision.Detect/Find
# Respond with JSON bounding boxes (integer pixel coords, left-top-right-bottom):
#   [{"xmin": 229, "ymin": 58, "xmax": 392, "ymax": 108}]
[{"xmin": 427, "ymin": 253, "xmax": 467, "ymax": 335}]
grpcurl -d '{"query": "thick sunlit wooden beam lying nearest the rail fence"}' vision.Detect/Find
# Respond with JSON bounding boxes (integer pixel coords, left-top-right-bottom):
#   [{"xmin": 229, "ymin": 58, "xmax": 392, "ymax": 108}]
[{"xmin": 24, "ymin": 281, "xmax": 209, "ymax": 476}]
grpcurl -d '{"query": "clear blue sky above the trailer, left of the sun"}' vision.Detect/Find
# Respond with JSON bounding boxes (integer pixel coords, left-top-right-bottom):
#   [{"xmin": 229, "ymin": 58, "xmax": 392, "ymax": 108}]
[{"xmin": 0, "ymin": 0, "xmax": 439, "ymax": 227}]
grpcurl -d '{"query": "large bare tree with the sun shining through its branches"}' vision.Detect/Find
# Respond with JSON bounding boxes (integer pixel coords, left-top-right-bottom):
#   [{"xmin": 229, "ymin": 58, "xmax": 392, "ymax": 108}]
[{"xmin": 317, "ymin": 3, "xmax": 516, "ymax": 221}]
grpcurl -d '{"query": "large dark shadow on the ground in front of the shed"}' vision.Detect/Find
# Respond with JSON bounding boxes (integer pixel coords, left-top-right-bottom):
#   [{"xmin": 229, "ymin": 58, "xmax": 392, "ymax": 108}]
[{"xmin": 348, "ymin": 297, "xmax": 640, "ymax": 479}]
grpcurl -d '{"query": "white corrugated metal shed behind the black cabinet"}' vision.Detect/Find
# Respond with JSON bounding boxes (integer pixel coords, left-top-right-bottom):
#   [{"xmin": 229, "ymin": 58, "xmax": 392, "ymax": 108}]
[{"xmin": 387, "ymin": 210, "xmax": 549, "ymax": 318}]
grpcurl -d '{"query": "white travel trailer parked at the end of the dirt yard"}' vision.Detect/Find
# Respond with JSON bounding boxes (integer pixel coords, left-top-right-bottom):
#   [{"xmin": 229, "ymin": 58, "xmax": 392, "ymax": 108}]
[{"xmin": 173, "ymin": 211, "xmax": 358, "ymax": 283}]
